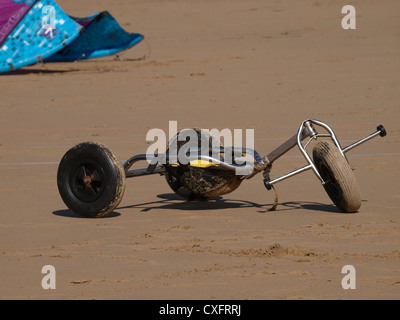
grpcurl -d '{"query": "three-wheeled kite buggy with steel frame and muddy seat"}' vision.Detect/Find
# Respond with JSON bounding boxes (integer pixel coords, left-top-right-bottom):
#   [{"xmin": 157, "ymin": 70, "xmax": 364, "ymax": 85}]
[{"xmin": 57, "ymin": 119, "xmax": 386, "ymax": 218}]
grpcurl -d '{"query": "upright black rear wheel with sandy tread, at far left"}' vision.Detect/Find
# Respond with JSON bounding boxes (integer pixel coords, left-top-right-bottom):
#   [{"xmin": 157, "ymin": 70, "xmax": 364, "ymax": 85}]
[{"xmin": 57, "ymin": 142, "xmax": 125, "ymax": 218}]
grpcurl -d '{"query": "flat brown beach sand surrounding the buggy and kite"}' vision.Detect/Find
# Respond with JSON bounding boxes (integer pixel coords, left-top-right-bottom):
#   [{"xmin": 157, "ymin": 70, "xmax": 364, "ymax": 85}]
[{"xmin": 0, "ymin": 0, "xmax": 400, "ymax": 300}]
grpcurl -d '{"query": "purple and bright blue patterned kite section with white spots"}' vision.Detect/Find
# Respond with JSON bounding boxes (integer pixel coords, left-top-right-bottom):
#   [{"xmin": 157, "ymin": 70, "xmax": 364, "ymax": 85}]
[{"xmin": 0, "ymin": 0, "xmax": 83, "ymax": 72}]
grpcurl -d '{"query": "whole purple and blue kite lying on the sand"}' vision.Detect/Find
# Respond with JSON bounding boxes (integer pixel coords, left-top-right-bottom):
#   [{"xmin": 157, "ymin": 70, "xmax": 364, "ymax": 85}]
[{"xmin": 0, "ymin": 0, "xmax": 143, "ymax": 73}]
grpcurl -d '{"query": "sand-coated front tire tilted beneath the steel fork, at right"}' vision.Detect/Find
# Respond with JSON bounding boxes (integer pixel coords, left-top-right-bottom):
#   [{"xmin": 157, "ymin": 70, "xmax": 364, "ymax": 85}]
[{"xmin": 313, "ymin": 141, "xmax": 361, "ymax": 213}]
